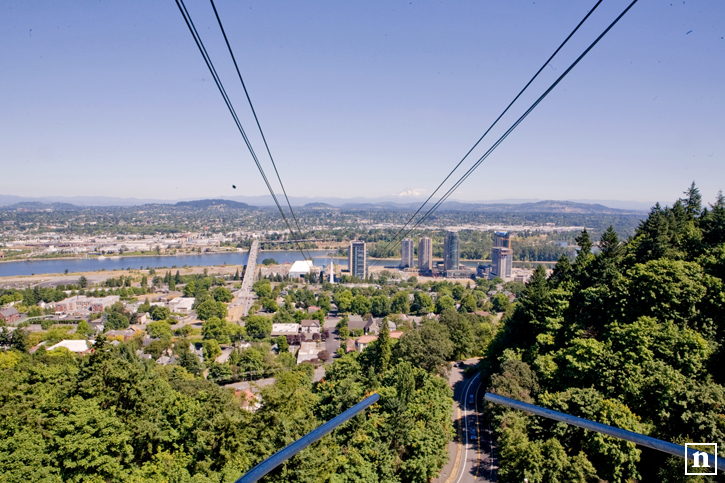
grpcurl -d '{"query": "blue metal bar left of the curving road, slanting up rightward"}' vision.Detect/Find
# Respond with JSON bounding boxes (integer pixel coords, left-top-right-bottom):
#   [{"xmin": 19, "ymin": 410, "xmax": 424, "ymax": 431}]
[{"xmin": 235, "ymin": 394, "xmax": 380, "ymax": 483}]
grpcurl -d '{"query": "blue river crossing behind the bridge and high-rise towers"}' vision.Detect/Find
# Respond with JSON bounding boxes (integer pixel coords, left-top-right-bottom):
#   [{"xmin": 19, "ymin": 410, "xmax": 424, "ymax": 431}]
[{"xmin": 0, "ymin": 250, "xmax": 492, "ymax": 277}]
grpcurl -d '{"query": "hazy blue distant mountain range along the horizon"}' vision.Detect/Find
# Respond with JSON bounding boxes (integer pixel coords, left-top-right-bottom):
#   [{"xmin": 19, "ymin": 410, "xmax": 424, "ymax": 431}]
[{"xmin": 0, "ymin": 195, "xmax": 651, "ymax": 215}]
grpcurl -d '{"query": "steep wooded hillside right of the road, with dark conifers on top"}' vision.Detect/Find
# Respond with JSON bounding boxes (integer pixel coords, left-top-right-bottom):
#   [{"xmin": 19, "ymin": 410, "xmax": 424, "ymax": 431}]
[{"xmin": 481, "ymin": 184, "xmax": 725, "ymax": 483}]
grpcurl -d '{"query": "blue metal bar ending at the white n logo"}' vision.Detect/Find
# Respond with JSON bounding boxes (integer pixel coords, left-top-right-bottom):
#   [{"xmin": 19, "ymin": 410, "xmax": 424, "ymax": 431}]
[{"xmin": 484, "ymin": 393, "xmax": 725, "ymax": 472}]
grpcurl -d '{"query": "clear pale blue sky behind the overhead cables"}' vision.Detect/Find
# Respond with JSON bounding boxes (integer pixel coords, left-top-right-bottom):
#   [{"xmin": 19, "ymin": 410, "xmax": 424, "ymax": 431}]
[{"xmin": 0, "ymin": 0, "xmax": 725, "ymax": 203}]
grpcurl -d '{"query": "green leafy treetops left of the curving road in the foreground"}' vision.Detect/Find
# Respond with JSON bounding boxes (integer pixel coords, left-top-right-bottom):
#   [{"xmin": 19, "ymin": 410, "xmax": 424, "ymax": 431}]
[{"xmin": 0, "ymin": 328, "xmax": 452, "ymax": 483}]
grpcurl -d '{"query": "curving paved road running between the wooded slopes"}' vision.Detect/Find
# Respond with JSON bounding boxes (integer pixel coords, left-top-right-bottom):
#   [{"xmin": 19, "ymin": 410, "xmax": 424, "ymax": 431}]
[{"xmin": 433, "ymin": 359, "xmax": 497, "ymax": 483}]
